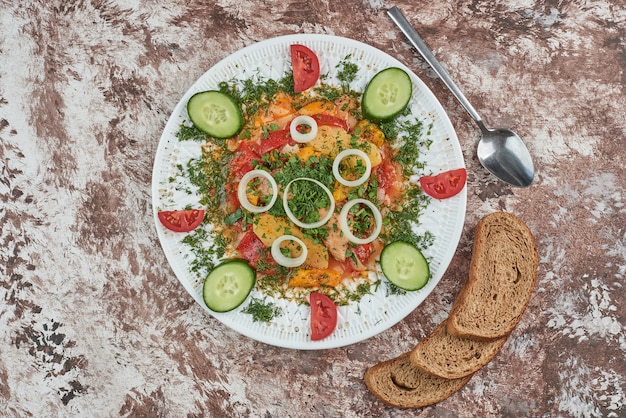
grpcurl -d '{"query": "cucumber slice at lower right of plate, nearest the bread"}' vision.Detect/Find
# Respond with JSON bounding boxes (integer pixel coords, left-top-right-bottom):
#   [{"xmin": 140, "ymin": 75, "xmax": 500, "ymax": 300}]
[{"xmin": 380, "ymin": 241, "xmax": 430, "ymax": 290}]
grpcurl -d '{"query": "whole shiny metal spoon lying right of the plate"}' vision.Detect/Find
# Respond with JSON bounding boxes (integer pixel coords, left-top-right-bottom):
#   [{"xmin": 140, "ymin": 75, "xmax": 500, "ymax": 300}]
[{"xmin": 387, "ymin": 6, "xmax": 535, "ymax": 187}]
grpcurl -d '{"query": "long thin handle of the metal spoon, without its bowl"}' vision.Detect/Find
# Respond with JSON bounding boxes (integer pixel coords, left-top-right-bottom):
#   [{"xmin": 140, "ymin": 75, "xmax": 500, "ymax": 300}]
[{"xmin": 387, "ymin": 6, "xmax": 484, "ymax": 128}]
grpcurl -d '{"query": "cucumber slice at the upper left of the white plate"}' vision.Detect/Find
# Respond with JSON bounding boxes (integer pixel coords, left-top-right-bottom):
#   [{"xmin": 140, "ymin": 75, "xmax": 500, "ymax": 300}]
[{"xmin": 187, "ymin": 90, "xmax": 244, "ymax": 139}]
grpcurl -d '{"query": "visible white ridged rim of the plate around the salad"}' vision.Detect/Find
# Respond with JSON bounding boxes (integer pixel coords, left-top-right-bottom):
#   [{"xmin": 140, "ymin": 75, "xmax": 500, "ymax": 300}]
[{"xmin": 152, "ymin": 34, "xmax": 467, "ymax": 349}]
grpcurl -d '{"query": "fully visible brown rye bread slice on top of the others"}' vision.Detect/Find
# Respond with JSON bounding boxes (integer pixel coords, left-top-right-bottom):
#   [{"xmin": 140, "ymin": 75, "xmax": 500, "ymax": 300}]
[{"xmin": 447, "ymin": 212, "xmax": 539, "ymax": 341}]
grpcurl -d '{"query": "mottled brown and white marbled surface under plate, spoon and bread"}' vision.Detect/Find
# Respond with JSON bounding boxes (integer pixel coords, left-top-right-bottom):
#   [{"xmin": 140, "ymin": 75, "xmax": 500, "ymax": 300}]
[{"xmin": 0, "ymin": 0, "xmax": 626, "ymax": 417}]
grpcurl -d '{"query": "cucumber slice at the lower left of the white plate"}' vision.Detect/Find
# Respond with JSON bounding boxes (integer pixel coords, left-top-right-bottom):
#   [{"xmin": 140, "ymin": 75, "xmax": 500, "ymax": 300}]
[{"xmin": 202, "ymin": 260, "xmax": 256, "ymax": 312}]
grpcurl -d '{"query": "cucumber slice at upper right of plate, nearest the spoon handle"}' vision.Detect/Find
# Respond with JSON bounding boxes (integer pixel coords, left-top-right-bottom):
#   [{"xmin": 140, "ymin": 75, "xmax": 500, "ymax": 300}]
[{"xmin": 363, "ymin": 67, "xmax": 413, "ymax": 122}]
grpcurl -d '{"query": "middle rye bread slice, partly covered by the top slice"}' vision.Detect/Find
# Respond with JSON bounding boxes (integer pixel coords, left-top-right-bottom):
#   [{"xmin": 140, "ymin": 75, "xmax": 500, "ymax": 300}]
[{"xmin": 410, "ymin": 321, "xmax": 507, "ymax": 379}]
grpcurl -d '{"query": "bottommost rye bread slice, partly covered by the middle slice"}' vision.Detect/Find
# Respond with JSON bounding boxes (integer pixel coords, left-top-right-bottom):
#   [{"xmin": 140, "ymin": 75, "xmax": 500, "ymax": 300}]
[{"xmin": 365, "ymin": 352, "xmax": 472, "ymax": 408}]
